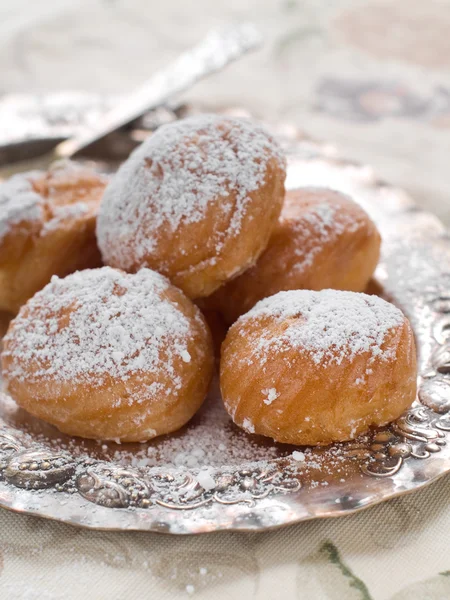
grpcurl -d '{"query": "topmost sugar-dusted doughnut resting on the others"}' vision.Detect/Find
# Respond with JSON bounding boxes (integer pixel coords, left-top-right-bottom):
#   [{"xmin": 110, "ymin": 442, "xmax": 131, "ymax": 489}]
[{"xmin": 97, "ymin": 115, "xmax": 286, "ymax": 298}]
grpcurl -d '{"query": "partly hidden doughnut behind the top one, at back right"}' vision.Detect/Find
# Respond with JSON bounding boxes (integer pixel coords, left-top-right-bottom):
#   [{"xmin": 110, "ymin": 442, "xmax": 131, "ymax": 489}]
[{"xmin": 205, "ymin": 188, "xmax": 380, "ymax": 323}]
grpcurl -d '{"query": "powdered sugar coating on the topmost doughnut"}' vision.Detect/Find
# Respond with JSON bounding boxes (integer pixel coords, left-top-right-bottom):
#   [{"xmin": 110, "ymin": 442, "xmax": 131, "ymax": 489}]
[{"xmin": 97, "ymin": 115, "xmax": 285, "ymax": 268}]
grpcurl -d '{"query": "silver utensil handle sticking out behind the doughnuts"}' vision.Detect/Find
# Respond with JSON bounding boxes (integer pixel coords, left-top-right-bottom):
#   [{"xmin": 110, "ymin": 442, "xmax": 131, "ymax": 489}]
[{"xmin": 53, "ymin": 24, "xmax": 262, "ymax": 158}]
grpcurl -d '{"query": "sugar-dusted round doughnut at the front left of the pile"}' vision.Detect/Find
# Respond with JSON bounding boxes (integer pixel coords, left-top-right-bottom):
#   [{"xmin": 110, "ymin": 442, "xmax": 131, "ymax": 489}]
[{"xmin": 2, "ymin": 267, "xmax": 214, "ymax": 441}]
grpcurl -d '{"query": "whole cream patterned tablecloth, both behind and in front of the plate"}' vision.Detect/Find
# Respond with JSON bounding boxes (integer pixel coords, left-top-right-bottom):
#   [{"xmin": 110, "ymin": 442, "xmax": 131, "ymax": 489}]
[{"xmin": 0, "ymin": 0, "xmax": 450, "ymax": 600}]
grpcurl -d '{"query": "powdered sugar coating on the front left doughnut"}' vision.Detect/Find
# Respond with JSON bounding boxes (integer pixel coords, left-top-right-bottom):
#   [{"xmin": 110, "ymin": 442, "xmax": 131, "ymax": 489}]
[{"xmin": 5, "ymin": 267, "xmax": 203, "ymax": 394}]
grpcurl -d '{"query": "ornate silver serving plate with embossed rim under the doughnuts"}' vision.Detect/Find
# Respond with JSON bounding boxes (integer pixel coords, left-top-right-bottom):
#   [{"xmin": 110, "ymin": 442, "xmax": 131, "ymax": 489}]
[{"xmin": 0, "ymin": 95, "xmax": 450, "ymax": 534}]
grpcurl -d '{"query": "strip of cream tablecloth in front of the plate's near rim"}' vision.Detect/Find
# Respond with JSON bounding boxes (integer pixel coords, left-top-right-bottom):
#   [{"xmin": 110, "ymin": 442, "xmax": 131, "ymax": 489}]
[{"xmin": 0, "ymin": 477, "xmax": 450, "ymax": 600}]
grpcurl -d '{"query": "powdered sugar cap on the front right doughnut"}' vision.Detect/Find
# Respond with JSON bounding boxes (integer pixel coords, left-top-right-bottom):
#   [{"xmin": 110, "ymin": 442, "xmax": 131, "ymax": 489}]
[{"xmin": 241, "ymin": 290, "xmax": 404, "ymax": 365}]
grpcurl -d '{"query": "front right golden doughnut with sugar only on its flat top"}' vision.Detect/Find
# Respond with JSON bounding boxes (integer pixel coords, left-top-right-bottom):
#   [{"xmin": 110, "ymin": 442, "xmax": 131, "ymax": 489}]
[{"xmin": 220, "ymin": 290, "xmax": 417, "ymax": 445}]
